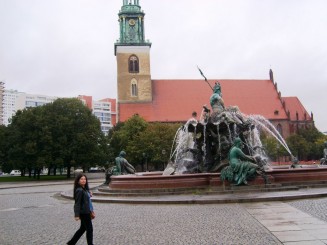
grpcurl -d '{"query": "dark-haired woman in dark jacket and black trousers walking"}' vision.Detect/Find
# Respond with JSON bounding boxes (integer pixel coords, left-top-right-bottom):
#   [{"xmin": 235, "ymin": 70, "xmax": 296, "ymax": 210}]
[{"xmin": 67, "ymin": 173, "xmax": 95, "ymax": 245}]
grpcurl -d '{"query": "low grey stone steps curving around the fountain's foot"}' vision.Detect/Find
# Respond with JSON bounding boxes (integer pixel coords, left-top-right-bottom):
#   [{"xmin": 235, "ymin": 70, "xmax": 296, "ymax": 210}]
[{"xmin": 61, "ymin": 181, "xmax": 327, "ymax": 204}]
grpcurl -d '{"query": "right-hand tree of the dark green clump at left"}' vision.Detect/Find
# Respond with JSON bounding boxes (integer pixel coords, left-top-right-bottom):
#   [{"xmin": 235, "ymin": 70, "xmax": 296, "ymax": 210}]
[{"xmin": 46, "ymin": 99, "xmax": 106, "ymax": 177}]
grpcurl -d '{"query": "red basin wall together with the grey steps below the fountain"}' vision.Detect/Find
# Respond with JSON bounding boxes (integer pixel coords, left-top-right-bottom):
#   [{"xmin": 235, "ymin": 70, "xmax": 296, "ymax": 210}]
[{"xmin": 61, "ymin": 165, "xmax": 327, "ymax": 204}]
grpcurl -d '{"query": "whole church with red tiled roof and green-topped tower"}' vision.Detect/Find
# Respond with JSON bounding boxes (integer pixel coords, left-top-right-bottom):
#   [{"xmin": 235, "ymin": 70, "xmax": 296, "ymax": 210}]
[{"xmin": 114, "ymin": 0, "xmax": 314, "ymax": 137}]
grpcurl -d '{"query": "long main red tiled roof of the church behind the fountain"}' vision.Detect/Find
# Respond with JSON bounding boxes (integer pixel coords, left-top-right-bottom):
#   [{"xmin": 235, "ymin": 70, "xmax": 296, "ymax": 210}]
[{"xmin": 119, "ymin": 79, "xmax": 294, "ymax": 122}]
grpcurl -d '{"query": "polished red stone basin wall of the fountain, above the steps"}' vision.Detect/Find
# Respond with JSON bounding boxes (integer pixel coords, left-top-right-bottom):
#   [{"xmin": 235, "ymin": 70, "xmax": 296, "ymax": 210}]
[{"xmin": 109, "ymin": 165, "xmax": 327, "ymax": 190}]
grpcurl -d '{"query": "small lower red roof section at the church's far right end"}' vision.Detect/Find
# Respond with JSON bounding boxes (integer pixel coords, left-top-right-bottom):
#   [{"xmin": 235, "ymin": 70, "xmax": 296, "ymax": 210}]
[{"xmin": 282, "ymin": 97, "xmax": 312, "ymax": 121}]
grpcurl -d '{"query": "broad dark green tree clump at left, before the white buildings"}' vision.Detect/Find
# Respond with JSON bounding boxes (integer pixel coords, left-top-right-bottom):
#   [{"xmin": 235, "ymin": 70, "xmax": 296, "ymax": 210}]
[{"xmin": 3, "ymin": 99, "xmax": 107, "ymax": 177}]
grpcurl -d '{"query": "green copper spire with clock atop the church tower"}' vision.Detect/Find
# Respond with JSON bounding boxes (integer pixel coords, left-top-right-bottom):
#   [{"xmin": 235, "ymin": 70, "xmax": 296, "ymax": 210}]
[{"xmin": 115, "ymin": 0, "xmax": 151, "ymax": 50}]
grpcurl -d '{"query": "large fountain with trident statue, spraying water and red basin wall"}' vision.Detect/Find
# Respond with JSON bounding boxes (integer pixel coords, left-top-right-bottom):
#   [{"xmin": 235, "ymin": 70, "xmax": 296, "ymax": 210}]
[{"xmin": 109, "ymin": 72, "xmax": 327, "ymax": 190}]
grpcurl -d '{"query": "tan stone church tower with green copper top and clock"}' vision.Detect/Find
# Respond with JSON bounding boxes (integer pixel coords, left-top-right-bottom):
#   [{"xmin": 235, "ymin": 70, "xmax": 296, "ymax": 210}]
[{"xmin": 115, "ymin": 0, "xmax": 152, "ymax": 120}]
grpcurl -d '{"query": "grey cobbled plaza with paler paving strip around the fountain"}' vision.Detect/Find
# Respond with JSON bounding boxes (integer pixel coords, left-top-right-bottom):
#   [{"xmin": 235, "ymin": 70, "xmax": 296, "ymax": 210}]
[{"xmin": 0, "ymin": 180, "xmax": 327, "ymax": 245}]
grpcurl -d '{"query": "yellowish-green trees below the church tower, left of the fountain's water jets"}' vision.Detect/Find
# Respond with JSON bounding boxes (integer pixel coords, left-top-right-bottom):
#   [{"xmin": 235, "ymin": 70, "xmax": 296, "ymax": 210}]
[{"xmin": 108, "ymin": 115, "xmax": 180, "ymax": 170}]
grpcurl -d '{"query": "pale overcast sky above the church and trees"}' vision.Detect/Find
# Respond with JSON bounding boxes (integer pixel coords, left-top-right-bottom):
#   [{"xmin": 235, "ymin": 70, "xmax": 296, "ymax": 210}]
[{"xmin": 0, "ymin": 0, "xmax": 327, "ymax": 131}]
